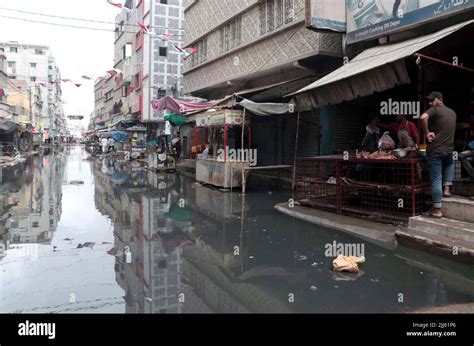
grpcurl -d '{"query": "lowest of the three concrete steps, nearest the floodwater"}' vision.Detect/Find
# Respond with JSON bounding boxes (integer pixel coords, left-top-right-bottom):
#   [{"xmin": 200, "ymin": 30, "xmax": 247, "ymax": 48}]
[{"xmin": 395, "ymin": 229, "xmax": 474, "ymax": 265}]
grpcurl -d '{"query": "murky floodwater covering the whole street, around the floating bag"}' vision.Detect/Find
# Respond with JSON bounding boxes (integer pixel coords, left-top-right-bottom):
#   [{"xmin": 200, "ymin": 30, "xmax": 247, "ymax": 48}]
[{"xmin": 0, "ymin": 147, "xmax": 474, "ymax": 313}]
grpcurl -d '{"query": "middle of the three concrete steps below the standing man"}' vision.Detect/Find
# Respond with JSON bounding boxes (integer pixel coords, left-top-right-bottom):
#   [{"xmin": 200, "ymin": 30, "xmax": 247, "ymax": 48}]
[{"xmin": 408, "ymin": 216, "xmax": 474, "ymax": 242}]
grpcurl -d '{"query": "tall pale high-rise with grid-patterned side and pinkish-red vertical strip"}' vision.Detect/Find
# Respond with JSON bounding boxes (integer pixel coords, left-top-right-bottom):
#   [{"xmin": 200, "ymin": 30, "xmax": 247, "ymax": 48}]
[{"xmin": 95, "ymin": 0, "xmax": 184, "ymax": 137}]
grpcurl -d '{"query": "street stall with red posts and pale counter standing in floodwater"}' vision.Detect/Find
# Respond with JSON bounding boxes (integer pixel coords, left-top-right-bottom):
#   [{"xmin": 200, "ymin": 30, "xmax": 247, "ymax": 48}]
[{"xmin": 196, "ymin": 109, "xmax": 251, "ymax": 188}]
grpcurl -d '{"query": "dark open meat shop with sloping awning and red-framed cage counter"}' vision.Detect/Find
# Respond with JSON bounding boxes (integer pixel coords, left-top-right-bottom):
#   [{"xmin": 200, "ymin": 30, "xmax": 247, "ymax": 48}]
[{"xmin": 292, "ymin": 20, "xmax": 474, "ymax": 219}]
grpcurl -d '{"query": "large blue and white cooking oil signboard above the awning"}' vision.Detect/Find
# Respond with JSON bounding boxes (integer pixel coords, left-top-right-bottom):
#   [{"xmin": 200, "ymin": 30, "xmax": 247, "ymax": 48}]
[{"xmin": 346, "ymin": 0, "xmax": 474, "ymax": 44}]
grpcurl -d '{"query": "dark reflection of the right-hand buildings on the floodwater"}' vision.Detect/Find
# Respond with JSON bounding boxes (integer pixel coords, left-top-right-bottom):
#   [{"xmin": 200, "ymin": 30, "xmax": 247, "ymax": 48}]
[{"xmin": 94, "ymin": 151, "xmax": 474, "ymax": 313}]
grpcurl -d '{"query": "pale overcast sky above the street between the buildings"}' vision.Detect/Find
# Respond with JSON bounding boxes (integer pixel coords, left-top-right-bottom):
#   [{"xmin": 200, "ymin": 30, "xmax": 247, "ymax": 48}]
[{"xmin": 0, "ymin": 0, "xmax": 120, "ymax": 125}]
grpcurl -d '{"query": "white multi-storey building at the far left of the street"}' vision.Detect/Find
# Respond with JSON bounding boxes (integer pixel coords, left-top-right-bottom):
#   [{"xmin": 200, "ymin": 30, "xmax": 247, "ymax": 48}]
[{"xmin": 0, "ymin": 41, "xmax": 65, "ymax": 137}]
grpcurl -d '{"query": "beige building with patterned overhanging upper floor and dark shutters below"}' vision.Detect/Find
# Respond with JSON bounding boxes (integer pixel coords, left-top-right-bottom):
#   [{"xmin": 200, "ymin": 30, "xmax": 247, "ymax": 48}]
[{"xmin": 184, "ymin": 0, "xmax": 342, "ymax": 165}]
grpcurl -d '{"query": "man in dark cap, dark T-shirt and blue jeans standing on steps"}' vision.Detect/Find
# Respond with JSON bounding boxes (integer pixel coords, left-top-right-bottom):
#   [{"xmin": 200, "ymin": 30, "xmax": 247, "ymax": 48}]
[{"xmin": 421, "ymin": 91, "xmax": 457, "ymax": 218}]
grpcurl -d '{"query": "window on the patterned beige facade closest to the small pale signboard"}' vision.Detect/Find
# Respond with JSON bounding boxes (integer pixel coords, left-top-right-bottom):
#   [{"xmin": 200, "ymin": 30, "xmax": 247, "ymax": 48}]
[{"xmin": 259, "ymin": 0, "xmax": 294, "ymax": 35}]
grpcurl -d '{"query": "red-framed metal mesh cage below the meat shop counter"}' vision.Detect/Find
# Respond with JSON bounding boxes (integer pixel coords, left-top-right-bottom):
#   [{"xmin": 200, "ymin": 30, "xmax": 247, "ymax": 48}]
[{"xmin": 295, "ymin": 157, "xmax": 430, "ymax": 220}]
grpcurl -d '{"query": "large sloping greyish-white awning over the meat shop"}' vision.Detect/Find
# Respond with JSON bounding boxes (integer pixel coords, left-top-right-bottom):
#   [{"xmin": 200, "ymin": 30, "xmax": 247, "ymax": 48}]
[{"xmin": 288, "ymin": 20, "xmax": 474, "ymax": 111}]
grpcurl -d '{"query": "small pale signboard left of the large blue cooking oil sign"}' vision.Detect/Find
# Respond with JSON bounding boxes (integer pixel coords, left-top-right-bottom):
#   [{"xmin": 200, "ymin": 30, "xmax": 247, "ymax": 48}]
[{"xmin": 306, "ymin": 0, "xmax": 346, "ymax": 33}]
